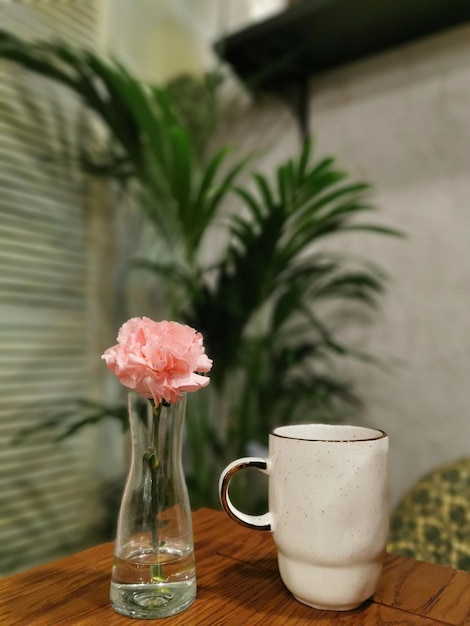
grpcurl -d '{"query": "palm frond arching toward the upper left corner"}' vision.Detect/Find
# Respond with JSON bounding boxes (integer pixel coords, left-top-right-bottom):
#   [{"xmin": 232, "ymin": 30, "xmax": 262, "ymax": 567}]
[{"xmin": 0, "ymin": 29, "xmax": 243, "ymax": 261}]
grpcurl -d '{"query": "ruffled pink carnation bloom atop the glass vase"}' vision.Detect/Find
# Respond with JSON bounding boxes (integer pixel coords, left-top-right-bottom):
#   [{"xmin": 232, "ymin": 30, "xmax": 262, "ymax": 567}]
[{"xmin": 101, "ymin": 317, "xmax": 212, "ymax": 406}]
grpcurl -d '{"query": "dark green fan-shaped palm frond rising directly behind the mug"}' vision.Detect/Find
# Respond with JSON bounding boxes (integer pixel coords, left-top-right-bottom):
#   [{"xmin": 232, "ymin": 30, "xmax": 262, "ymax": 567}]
[{"xmin": 186, "ymin": 143, "xmax": 392, "ymax": 455}]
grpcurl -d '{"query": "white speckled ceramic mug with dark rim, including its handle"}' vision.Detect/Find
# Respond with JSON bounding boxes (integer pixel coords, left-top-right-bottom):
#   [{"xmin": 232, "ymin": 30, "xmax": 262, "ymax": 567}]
[{"xmin": 219, "ymin": 424, "xmax": 389, "ymax": 611}]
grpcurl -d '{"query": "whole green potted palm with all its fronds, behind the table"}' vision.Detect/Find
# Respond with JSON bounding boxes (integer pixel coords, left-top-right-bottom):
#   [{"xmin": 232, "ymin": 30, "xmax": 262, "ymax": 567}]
[{"xmin": 0, "ymin": 31, "xmax": 397, "ymax": 504}]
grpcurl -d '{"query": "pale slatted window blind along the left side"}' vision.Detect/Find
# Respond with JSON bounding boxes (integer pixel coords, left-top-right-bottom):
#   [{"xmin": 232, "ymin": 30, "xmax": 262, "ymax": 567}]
[{"xmin": 0, "ymin": 0, "xmax": 106, "ymax": 575}]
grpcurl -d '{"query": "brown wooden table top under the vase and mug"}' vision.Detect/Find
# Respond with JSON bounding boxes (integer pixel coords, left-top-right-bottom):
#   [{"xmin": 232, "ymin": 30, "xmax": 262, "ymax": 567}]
[{"xmin": 0, "ymin": 509, "xmax": 470, "ymax": 626}]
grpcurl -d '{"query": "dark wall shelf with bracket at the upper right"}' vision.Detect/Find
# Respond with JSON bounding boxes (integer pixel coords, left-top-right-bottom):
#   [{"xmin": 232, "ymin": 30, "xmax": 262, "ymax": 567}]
[{"xmin": 214, "ymin": 0, "xmax": 470, "ymax": 135}]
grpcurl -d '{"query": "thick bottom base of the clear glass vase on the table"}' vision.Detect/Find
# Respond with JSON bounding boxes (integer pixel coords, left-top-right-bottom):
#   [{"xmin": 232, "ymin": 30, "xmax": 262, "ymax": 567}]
[{"xmin": 110, "ymin": 578, "xmax": 196, "ymax": 619}]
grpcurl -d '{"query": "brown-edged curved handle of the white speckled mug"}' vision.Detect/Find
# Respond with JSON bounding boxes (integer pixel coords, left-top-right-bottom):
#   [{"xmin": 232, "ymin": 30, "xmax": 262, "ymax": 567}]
[{"xmin": 219, "ymin": 456, "xmax": 272, "ymax": 530}]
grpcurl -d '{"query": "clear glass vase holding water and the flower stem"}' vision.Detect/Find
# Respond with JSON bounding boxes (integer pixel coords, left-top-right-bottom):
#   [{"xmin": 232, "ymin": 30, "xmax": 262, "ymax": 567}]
[{"xmin": 110, "ymin": 392, "xmax": 196, "ymax": 619}]
